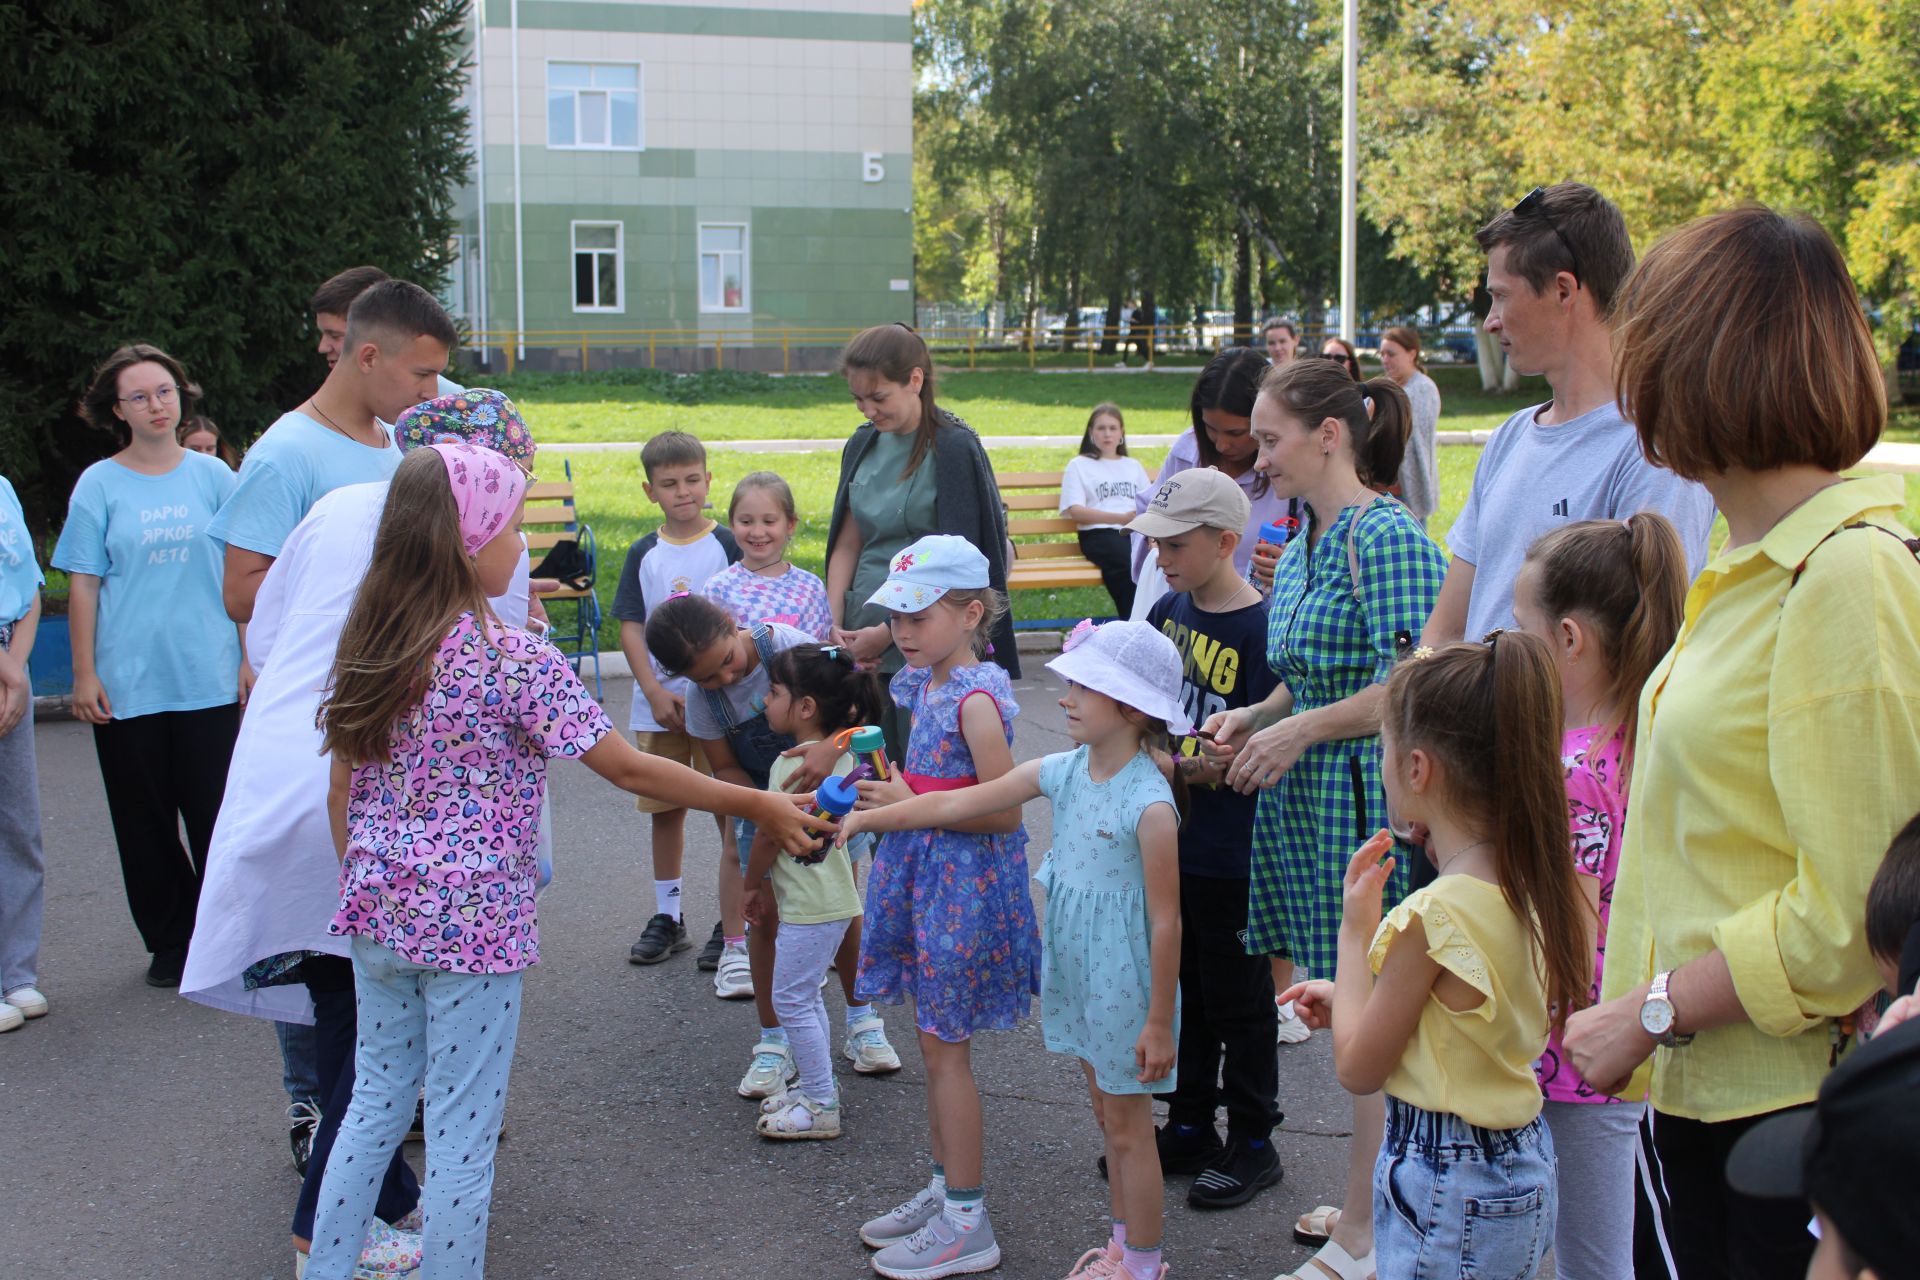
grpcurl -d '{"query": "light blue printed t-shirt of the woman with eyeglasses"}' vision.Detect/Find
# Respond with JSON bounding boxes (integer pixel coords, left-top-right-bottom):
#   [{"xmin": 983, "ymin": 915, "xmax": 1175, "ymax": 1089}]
[{"xmin": 54, "ymin": 451, "xmax": 240, "ymax": 720}]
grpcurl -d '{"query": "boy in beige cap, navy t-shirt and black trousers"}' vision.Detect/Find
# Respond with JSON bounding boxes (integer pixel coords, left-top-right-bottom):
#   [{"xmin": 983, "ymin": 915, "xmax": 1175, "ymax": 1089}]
[{"xmin": 1127, "ymin": 468, "xmax": 1281, "ymax": 1209}]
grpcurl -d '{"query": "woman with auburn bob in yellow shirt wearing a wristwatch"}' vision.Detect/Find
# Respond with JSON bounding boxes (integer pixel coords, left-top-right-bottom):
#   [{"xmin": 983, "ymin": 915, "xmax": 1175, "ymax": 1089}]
[{"xmin": 1567, "ymin": 207, "xmax": 1920, "ymax": 1280}]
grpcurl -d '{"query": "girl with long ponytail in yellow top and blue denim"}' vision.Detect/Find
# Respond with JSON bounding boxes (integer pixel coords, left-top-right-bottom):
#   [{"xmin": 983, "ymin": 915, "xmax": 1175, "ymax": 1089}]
[{"xmin": 1281, "ymin": 631, "xmax": 1594, "ymax": 1276}]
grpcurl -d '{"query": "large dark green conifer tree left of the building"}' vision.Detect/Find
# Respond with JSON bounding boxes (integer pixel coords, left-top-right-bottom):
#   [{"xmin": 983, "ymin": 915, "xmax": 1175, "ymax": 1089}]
[{"xmin": 0, "ymin": 0, "xmax": 468, "ymax": 530}]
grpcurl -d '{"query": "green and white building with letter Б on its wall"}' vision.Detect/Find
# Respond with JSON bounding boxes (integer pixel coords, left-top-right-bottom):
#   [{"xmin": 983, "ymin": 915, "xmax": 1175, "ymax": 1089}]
[{"xmin": 449, "ymin": 0, "xmax": 914, "ymax": 368}]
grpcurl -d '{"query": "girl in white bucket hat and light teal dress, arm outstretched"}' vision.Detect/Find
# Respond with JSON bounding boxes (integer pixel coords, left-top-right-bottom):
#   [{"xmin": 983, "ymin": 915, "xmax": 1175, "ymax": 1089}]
[{"xmin": 841, "ymin": 622, "xmax": 1192, "ymax": 1280}]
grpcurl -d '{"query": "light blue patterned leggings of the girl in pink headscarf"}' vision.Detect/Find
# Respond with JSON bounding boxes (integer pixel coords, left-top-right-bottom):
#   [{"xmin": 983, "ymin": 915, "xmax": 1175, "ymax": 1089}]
[{"xmin": 307, "ymin": 936, "xmax": 520, "ymax": 1280}]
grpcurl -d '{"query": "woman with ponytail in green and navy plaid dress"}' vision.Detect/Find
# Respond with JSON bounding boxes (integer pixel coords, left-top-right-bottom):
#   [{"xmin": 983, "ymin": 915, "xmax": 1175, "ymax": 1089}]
[{"xmin": 1204, "ymin": 361, "xmax": 1446, "ymax": 1280}]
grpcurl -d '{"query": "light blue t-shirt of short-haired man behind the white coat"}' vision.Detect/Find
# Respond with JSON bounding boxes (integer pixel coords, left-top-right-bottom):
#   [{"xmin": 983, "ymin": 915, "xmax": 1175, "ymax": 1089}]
[{"xmin": 207, "ymin": 413, "xmax": 399, "ymax": 557}]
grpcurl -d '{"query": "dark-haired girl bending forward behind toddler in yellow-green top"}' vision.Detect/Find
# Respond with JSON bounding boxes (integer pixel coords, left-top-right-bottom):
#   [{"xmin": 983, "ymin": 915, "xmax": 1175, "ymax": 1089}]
[{"xmin": 647, "ymin": 595, "xmax": 890, "ymax": 1098}]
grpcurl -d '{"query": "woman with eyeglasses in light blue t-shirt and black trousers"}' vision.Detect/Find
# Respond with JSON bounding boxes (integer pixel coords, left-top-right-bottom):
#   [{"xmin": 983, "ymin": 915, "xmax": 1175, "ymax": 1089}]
[{"xmin": 54, "ymin": 344, "xmax": 250, "ymax": 986}]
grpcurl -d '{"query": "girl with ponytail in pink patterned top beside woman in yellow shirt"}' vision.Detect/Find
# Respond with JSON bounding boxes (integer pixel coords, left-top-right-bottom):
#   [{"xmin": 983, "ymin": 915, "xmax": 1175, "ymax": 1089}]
[{"xmin": 1513, "ymin": 510, "xmax": 1686, "ymax": 1280}]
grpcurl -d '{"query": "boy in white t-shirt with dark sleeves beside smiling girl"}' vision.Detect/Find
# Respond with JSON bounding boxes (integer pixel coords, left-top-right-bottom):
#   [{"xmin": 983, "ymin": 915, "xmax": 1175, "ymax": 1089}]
[{"xmin": 612, "ymin": 432, "xmax": 753, "ymax": 1000}]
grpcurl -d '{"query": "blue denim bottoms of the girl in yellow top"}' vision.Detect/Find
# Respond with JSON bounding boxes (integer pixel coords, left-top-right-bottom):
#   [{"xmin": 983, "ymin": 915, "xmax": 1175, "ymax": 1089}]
[{"xmin": 1373, "ymin": 1096, "xmax": 1559, "ymax": 1280}]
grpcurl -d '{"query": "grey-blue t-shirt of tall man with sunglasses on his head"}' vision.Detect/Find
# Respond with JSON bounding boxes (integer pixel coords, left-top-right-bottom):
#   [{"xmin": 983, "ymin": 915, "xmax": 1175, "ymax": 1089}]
[{"xmin": 1446, "ymin": 401, "xmax": 1713, "ymax": 641}]
